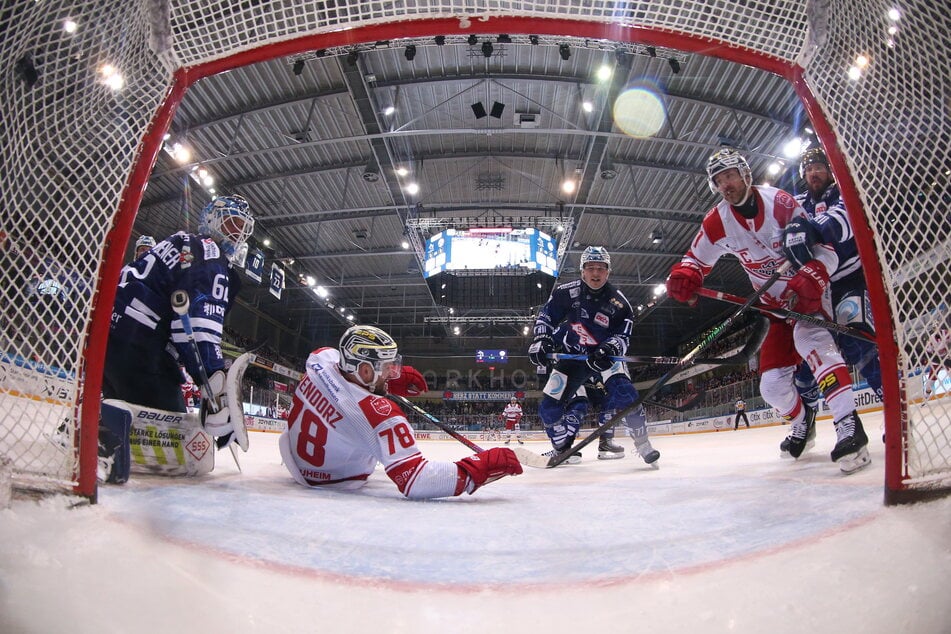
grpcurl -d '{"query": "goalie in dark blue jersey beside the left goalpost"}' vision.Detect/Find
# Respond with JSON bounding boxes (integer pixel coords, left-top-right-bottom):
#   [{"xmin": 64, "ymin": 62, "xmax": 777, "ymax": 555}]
[{"xmin": 93, "ymin": 196, "xmax": 254, "ymax": 484}]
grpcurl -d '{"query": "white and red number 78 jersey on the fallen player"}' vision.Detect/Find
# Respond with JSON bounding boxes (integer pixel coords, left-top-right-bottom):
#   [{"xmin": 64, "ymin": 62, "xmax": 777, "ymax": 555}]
[{"xmin": 280, "ymin": 348, "xmax": 458, "ymax": 497}]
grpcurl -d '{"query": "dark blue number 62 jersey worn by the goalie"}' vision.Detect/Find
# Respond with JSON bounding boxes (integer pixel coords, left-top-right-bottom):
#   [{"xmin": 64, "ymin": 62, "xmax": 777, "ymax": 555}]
[{"xmin": 109, "ymin": 232, "xmax": 241, "ymax": 377}]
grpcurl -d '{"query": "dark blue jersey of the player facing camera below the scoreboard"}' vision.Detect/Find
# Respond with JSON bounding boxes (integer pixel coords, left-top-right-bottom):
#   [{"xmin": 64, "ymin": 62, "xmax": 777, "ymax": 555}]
[{"xmin": 534, "ymin": 279, "xmax": 634, "ymax": 355}]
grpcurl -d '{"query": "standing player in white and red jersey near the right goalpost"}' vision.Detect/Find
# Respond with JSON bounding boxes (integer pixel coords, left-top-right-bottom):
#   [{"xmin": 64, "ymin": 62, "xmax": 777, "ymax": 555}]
[{"xmin": 667, "ymin": 149, "xmax": 870, "ymax": 473}]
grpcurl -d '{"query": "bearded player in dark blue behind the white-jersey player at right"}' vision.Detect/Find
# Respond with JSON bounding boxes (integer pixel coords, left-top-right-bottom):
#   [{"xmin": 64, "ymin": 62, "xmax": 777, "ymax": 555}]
[{"xmin": 780, "ymin": 147, "xmax": 882, "ymax": 453}]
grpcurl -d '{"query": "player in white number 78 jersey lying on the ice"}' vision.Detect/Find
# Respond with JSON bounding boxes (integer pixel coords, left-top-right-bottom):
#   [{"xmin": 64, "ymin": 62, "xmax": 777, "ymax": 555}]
[{"xmin": 279, "ymin": 326, "xmax": 522, "ymax": 499}]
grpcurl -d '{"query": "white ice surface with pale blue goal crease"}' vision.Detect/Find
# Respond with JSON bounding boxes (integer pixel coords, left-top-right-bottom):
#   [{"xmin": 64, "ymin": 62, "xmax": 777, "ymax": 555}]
[{"xmin": 0, "ymin": 404, "xmax": 951, "ymax": 634}]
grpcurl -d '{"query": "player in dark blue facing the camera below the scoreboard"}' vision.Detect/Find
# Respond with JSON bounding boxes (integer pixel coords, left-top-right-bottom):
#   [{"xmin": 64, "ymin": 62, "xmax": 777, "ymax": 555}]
[{"xmin": 528, "ymin": 246, "xmax": 660, "ymax": 464}]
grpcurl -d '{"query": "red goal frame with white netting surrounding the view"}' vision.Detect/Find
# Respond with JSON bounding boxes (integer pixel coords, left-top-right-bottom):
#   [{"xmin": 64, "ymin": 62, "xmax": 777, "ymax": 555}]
[{"xmin": 0, "ymin": 0, "xmax": 951, "ymax": 502}]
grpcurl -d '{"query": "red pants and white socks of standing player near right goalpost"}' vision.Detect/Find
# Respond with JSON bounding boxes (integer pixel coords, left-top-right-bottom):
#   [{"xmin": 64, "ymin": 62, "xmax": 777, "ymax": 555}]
[{"xmin": 760, "ymin": 319, "xmax": 855, "ymax": 422}]
